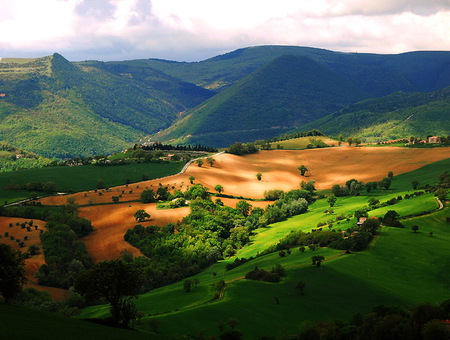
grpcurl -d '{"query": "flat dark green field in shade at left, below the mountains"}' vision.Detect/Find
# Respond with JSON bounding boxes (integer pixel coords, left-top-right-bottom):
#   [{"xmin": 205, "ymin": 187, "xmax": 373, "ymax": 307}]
[{"xmin": 0, "ymin": 163, "xmax": 184, "ymax": 202}]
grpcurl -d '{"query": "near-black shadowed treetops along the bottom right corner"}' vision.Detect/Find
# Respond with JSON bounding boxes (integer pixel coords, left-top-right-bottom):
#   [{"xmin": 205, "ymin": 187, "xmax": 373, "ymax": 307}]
[{"xmin": 297, "ymin": 300, "xmax": 450, "ymax": 340}]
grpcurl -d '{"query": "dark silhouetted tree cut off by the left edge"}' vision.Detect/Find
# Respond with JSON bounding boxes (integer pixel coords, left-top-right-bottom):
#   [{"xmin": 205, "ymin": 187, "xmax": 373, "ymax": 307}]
[{"xmin": 0, "ymin": 243, "xmax": 27, "ymax": 303}]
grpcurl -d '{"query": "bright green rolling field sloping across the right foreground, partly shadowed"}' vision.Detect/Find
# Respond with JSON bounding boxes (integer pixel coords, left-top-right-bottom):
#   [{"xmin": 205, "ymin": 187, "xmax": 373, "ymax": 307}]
[{"xmin": 76, "ymin": 159, "xmax": 450, "ymax": 338}]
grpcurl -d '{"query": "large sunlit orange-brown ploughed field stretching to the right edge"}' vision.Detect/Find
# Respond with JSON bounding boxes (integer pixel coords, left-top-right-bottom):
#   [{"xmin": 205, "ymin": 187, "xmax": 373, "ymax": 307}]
[{"xmin": 35, "ymin": 146, "xmax": 450, "ymax": 262}]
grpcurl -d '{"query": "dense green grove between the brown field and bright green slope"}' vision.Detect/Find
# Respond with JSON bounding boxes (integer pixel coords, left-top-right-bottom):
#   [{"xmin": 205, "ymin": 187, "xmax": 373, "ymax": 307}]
[{"xmin": 125, "ymin": 184, "xmax": 313, "ymax": 289}]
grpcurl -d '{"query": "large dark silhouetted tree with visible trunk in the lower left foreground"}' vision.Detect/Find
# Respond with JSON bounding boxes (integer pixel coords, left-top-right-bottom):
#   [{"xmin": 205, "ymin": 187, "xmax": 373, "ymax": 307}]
[{"xmin": 75, "ymin": 259, "xmax": 144, "ymax": 327}]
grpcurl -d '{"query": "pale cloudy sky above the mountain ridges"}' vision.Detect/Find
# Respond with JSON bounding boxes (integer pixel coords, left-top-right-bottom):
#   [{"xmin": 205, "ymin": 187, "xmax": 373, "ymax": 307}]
[{"xmin": 0, "ymin": 0, "xmax": 450, "ymax": 61}]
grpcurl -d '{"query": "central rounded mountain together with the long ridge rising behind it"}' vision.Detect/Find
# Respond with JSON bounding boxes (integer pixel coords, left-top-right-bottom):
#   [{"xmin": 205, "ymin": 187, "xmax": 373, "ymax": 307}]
[{"xmin": 147, "ymin": 46, "xmax": 450, "ymax": 147}]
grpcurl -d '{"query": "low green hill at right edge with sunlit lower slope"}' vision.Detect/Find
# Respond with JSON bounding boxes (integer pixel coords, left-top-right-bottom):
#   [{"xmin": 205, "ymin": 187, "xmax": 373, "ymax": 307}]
[{"xmin": 301, "ymin": 87, "xmax": 450, "ymax": 142}]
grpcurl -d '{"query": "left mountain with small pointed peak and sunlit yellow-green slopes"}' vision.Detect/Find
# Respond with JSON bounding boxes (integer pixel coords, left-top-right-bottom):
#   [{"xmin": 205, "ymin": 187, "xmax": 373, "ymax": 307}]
[{"xmin": 0, "ymin": 53, "xmax": 213, "ymax": 158}]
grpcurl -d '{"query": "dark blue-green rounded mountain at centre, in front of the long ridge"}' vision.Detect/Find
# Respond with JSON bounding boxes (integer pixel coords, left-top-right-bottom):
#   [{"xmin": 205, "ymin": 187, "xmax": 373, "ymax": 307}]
[{"xmin": 154, "ymin": 56, "xmax": 367, "ymax": 147}]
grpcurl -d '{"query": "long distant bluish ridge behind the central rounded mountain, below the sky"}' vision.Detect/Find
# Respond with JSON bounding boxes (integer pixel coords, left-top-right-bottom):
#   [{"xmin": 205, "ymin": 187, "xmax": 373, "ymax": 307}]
[{"xmin": 135, "ymin": 46, "xmax": 450, "ymax": 97}]
